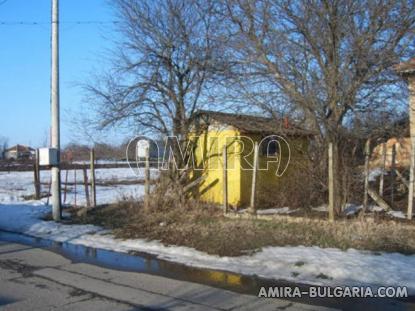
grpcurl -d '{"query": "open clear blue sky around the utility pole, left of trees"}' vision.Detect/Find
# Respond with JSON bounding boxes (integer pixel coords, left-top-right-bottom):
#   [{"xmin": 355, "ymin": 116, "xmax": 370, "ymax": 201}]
[{"xmin": 0, "ymin": 0, "xmax": 115, "ymax": 147}]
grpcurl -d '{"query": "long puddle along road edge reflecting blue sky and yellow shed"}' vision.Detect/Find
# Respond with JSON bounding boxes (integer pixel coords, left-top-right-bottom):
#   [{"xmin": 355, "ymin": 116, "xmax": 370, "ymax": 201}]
[{"xmin": 0, "ymin": 231, "xmax": 415, "ymax": 310}]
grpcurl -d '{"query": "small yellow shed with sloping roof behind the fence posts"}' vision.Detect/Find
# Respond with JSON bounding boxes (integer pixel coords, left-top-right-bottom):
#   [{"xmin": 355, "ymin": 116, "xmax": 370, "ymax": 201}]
[{"xmin": 192, "ymin": 111, "xmax": 311, "ymax": 208}]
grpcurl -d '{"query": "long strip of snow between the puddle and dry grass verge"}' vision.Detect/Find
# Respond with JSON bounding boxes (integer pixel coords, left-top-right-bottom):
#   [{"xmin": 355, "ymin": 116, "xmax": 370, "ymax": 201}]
[{"xmin": 0, "ymin": 201, "xmax": 415, "ymax": 294}]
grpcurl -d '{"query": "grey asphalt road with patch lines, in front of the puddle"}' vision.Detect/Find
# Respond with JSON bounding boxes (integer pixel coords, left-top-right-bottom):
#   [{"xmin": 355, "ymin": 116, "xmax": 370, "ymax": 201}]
[{"xmin": 0, "ymin": 242, "xmax": 334, "ymax": 311}]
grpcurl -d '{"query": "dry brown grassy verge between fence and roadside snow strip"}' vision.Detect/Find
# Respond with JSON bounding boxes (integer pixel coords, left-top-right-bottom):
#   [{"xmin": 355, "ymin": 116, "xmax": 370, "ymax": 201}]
[{"xmin": 70, "ymin": 201, "xmax": 415, "ymax": 256}]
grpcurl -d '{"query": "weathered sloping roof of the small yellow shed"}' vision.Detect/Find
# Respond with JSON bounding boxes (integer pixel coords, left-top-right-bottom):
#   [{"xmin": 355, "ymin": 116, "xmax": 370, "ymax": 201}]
[{"xmin": 196, "ymin": 110, "xmax": 314, "ymax": 136}]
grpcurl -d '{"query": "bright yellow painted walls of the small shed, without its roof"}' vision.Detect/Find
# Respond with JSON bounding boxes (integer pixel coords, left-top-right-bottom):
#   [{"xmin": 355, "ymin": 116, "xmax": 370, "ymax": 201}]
[{"xmin": 194, "ymin": 127, "xmax": 307, "ymax": 207}]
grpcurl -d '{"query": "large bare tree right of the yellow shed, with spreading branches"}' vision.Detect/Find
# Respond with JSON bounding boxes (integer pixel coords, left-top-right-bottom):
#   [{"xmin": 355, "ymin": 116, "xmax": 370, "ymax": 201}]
[{"xmin": 223, "ymin": 0, "xmax": 415, "ymax": 211}]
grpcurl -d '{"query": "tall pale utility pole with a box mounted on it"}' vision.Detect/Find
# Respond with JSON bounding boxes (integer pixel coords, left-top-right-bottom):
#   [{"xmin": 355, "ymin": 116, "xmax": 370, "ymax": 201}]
[{"xmin": 50, "ymin": 0, "xmax": 62, "ymax": 221}]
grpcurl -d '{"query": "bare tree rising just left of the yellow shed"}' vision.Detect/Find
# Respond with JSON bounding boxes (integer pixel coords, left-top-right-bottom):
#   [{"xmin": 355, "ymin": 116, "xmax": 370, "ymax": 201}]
[{"xmin": 86, "ymin": 0, "xmax": 226, "ymax": 168}]
